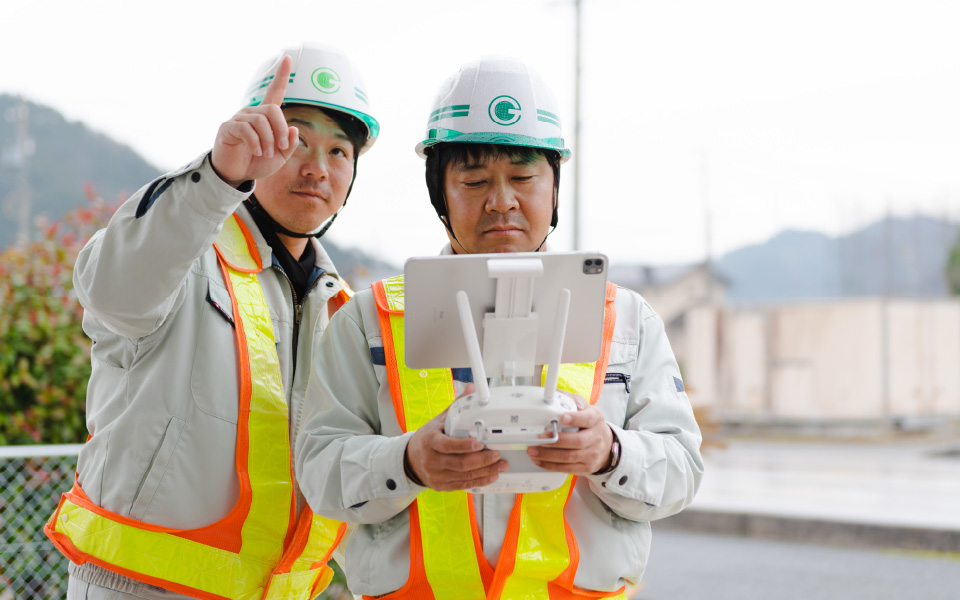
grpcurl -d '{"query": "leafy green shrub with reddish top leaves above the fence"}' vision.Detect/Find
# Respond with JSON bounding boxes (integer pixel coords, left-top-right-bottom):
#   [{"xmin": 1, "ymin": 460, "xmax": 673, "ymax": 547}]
[{"xmin": 0, "ymin": 186, "xmax": 120, "ymax": 445}]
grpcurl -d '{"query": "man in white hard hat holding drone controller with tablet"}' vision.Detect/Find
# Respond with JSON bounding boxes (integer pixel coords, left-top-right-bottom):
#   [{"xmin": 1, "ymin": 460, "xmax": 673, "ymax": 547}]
[{"xmin": 295, "ymin": 59, "xmax": 703, "ymax": 600}]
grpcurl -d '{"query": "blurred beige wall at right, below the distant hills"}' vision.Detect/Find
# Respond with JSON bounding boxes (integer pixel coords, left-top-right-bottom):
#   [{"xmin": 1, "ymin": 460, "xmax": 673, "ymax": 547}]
[{"xmin": 678, "ymin": 298, "xmax": 960, "ymax": 421}]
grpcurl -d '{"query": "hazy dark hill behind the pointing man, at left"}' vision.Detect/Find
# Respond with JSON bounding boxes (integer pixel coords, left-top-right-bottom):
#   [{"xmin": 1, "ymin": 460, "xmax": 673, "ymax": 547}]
[{"xmin": 0, "ymin": 94, "xmax": 403, "ymax": 289}]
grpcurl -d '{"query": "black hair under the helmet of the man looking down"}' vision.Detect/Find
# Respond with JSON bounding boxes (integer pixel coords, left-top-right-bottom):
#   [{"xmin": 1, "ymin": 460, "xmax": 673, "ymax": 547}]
[{"xmin": 425, "ymin": 142, "xmax": 560, "ymax": 239}]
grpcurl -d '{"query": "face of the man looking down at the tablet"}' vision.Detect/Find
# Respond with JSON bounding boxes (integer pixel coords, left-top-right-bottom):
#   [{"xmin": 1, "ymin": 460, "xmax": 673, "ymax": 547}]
[{"xmin": 443, "ymin": 154, "xmax": 553, "ymax": 254}]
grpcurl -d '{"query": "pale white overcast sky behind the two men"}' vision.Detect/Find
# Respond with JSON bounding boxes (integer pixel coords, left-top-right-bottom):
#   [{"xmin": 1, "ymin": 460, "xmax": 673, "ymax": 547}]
[{"xmin": 0, "ymin": 0, "xmax": 960, "ymax": 265}]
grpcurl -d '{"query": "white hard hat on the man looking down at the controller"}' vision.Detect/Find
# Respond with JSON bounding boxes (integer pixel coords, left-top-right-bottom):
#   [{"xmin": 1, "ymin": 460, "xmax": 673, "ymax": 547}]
[{"xmin": 416, "ymin": 57, "xmax": 570, "ymax": 162}]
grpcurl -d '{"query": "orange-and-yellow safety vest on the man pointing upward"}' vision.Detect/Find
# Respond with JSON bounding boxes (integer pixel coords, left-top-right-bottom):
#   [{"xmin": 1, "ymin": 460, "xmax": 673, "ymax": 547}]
[{"xmin": 44, "ymin": 215, "xmax": 346, "ymax": 600}]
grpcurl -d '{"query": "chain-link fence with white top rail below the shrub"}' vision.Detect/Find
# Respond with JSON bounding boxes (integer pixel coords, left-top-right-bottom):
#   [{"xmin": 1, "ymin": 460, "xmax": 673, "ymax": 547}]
[{"xmin": 0, "ymin": 444, "xmax": 81, "ymax": 600}]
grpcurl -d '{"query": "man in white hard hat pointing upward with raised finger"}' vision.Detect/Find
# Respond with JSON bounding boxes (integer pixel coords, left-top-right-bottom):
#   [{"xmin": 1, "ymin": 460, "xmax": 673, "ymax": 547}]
[{"xmin": 45, "ymin": 44, "xmax": 379, "ymax": 600}]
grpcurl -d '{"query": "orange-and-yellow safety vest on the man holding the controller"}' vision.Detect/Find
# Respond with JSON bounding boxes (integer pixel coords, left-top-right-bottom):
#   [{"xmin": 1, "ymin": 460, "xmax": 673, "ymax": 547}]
[{"xmin": 372, "ymin": 277, "xmax": 626, "ymax": 600}]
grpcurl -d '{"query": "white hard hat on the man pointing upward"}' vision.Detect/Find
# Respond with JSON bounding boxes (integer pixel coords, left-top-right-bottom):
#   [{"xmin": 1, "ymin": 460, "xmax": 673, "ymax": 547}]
[{"xmin": 244, "ymin": 42, "xmax": 380, "ymax": 154}]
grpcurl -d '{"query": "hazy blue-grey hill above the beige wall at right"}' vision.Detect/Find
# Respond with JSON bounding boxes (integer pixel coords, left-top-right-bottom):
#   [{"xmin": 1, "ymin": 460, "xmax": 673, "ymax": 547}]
[{"xmin": 716, "ymin": 216, "xmax": 960, "ymax": 302}]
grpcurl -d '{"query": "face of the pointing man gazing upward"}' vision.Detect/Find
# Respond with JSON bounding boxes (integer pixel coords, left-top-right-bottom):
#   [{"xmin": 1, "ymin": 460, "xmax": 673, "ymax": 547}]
[{"xmin": 256, "ymin": 106, "xmax": 353, "ymax": 233}]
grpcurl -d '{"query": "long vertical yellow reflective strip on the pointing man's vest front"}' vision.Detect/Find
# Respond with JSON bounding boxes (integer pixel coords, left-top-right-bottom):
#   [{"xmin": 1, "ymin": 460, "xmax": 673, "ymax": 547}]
[{"xmin": 228, "ymin": 268, "xmax": 293, "ymax": 564}]
